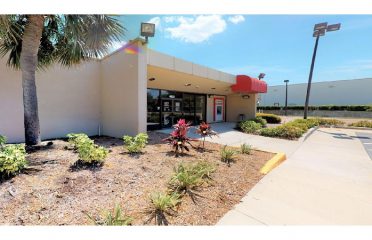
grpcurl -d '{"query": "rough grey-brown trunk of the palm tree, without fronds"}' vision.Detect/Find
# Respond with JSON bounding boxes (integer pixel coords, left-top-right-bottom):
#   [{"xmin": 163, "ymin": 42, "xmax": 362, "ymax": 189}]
[{"xmin": 20, "ymin": 15, "xmax": 44, "ymax": 145}]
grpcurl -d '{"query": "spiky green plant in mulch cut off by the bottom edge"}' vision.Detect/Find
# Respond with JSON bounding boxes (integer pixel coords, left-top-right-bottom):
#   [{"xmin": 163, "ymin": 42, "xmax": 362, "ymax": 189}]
[{"xmin": 87, "ymin": 204, "xmax": 133, "ymax": 226}]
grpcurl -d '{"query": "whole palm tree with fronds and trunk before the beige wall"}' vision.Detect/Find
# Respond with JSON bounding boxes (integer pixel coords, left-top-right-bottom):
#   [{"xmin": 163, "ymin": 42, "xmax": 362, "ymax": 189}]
[{"xmin": 0, "ymin": 15, "xmax": 125, "ymax": 145}]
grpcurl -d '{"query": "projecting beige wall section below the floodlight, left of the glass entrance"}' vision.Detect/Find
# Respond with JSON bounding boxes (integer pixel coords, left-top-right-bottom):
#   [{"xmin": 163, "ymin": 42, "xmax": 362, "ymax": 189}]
[{"xmin": 101, "ymin": 42, "xmax": 147, "ymax": 137}]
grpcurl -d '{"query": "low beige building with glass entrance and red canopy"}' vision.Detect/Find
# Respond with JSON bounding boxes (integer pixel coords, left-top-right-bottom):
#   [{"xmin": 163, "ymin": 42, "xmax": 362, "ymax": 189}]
[{"xmin": 0, "ymin": 40, "xmax": 267, "ymax": 142}]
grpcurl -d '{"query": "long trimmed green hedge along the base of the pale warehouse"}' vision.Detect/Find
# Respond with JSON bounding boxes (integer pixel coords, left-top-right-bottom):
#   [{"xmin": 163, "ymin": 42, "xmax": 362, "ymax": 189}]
[{"xmin": 257, "ymin": 105, "xmax": 372, "ymax": 112}]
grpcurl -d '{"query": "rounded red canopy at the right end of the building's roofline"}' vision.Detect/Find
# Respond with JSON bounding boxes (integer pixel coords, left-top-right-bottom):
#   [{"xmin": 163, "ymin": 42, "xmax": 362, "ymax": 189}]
[{"xmin": 231, "ymin": 75, "xmax": 267, "ymax": 93}]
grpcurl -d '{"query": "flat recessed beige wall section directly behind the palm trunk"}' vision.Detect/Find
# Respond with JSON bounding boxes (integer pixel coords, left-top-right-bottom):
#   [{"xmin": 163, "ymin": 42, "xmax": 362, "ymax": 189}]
[{"xmin": 0, "ymin": 57, "xmax": 100, "ymax": 142}]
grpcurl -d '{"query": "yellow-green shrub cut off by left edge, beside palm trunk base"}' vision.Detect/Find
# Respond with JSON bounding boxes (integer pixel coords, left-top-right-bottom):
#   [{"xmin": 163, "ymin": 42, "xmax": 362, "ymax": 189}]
[{"xmin": 0, "ymin": 144, "xmax": 28, "ymax": 176}]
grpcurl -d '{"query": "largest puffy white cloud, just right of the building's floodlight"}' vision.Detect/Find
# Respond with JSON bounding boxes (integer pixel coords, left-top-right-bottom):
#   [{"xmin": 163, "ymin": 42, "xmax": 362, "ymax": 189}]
[{"xmin": 165, "ymin": 15, "xmax": 226, "ymax": 43}]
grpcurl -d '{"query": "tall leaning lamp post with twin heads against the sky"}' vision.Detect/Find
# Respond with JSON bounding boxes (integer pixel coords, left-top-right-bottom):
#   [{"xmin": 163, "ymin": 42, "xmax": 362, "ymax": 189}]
[{"xmin": 304, "ymin": 22, "xmax": 341, "ymax": 119}]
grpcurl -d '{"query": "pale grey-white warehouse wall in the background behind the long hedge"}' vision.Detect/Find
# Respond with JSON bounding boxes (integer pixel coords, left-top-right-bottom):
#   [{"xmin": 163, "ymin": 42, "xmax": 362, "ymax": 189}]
[{"xmin": 260, "ymin": 78, "xmax": 372, "ymax": 106}]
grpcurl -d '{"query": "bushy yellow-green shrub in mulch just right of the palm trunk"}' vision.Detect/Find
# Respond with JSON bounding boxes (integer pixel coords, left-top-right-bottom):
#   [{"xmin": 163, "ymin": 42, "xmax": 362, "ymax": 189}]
[{"xmin": 67, "ymin": 133, "xmax": 108, "ymax": 164}]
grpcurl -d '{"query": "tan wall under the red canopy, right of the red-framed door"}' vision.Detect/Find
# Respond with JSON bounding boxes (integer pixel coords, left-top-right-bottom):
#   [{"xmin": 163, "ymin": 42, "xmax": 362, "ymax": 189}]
[{"xmin": 226, "ymin": 94, "xmax": 257, "ymax": 122}]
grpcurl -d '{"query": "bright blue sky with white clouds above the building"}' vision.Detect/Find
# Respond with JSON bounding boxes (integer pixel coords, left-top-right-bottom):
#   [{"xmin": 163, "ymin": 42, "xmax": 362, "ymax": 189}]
[{"xmin": 114, "ymin": 15, "xmax": 372, "ymax": 85}]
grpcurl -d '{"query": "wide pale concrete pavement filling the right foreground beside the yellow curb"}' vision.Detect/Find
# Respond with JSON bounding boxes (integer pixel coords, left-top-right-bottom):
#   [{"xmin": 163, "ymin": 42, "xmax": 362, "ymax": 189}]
[{"xmin": 218, "ymin": 128, "xmax": 372, "ymax": 225}]
